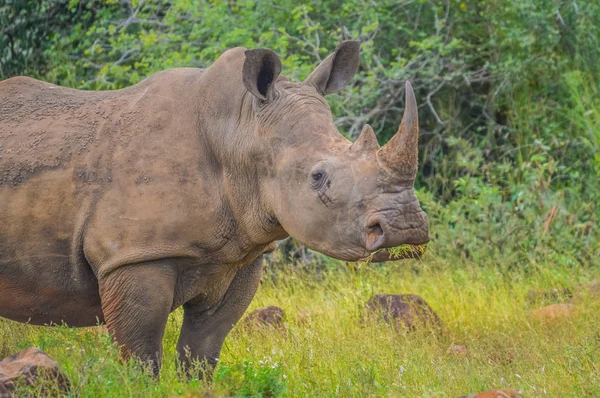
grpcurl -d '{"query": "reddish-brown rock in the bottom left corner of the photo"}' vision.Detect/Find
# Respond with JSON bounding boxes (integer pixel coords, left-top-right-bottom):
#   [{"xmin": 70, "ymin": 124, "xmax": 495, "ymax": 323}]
[{"xmin": 0, "ymin": 347, "xmax": 70, "ymax": 398}]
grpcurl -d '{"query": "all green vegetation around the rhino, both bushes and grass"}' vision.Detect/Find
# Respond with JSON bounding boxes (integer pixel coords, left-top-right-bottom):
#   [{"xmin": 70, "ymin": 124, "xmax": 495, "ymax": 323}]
[{"xmin": 0, "ymin": 0, "xmax": 600, "ymax": 397}]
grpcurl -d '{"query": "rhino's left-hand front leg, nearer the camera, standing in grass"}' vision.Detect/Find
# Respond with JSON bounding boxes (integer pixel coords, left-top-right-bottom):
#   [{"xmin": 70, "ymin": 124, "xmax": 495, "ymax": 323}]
[{"xmin": 99, "ymin": 261, "xmax": 177, "ymax": 376}]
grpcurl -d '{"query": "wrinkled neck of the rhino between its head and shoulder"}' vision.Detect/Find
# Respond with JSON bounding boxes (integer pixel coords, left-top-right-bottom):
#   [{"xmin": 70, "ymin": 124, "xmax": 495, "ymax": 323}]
[{"xmin": 192, "ymin": 48, "xmax": 287, "ymax": 245}]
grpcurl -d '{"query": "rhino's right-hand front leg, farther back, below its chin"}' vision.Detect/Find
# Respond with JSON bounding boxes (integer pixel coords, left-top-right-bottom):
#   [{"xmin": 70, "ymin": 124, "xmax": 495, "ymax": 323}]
[{"xmin": 177, "ymin": 256, "xmax": 262, "ymax": 377}]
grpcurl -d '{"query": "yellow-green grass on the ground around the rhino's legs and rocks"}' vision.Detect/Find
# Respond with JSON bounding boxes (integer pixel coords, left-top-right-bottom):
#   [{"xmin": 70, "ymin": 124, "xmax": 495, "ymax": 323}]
[{"xmin": 0, "ymin": 255, "xmax": 600, "ymax": 397}]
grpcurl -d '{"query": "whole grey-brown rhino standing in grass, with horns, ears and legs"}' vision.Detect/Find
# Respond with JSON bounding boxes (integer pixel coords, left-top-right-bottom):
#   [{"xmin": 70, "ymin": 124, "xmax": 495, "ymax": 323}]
[{"xmin": 0, "ymin": 41, "xmax": 428, "ymax": 374}]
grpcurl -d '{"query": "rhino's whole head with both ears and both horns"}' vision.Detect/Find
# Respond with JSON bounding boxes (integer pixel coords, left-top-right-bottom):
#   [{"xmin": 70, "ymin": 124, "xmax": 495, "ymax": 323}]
[{"xmin": 243, "ymin": 41, "xmax": 429, "ymax": 261}]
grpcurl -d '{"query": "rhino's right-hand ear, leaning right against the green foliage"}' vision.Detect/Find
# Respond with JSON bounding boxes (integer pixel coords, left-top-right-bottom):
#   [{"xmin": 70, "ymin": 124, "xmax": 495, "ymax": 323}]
[{"xmin": 304, "ymin": 40, "xmax": 360, "ymax": 95}]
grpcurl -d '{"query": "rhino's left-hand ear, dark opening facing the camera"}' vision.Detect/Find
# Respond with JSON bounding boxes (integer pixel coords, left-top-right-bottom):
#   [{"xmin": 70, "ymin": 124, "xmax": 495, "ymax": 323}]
[{"xmin": 242, "ymin": 48, "xmax": 281, "ymax": 100}]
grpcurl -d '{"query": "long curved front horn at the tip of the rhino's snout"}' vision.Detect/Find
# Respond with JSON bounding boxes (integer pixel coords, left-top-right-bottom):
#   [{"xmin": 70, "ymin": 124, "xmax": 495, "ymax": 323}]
[{"xmin": 377, "ymin": 81, "xmax": 419, "ymax": 178}]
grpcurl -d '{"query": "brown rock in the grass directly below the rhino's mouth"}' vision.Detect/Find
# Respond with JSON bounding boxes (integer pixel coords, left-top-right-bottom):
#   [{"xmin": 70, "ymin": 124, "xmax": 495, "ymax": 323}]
[{"xmin": 365, "ymin": 294, "xmax": 443, "ymax": 331}]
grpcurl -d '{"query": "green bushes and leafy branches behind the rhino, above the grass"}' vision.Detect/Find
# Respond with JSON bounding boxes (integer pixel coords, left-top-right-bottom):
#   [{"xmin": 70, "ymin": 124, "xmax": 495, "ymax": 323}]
[{"xmin": 0, "ymin": 0, "xmax": 600, "ymax": 264}]
